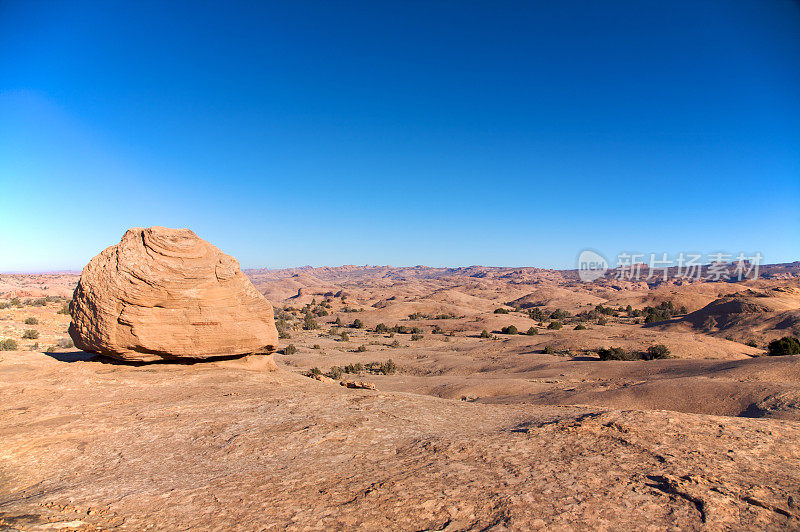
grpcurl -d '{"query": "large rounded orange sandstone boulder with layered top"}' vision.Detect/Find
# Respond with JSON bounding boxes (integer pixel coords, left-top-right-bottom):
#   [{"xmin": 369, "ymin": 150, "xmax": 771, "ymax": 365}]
[{"xmin": 69, "ymin": 227, "xmax": 278, "ymax": 361}]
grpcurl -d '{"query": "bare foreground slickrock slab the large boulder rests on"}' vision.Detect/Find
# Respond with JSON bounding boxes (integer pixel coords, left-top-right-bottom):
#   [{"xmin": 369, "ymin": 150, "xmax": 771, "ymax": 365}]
[{"xmin": 0, "ymin": 352, "xmax": 800, "ymax": 530}]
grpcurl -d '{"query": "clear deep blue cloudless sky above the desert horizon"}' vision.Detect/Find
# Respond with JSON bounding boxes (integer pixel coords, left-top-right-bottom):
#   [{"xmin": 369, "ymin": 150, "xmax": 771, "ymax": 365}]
[{"xmin": 0, "ymin": 0, "xmax": 800, "ymax": 271}]
